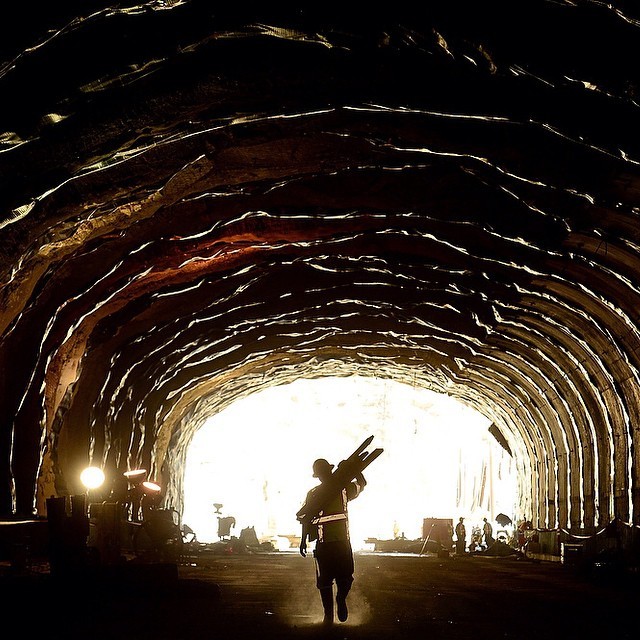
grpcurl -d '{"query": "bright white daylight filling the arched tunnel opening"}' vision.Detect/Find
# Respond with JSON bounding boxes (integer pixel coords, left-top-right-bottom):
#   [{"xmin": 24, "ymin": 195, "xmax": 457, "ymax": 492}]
[{"xmin": 183, "ymin": 376, "xmax": 520, "ymax": 551}]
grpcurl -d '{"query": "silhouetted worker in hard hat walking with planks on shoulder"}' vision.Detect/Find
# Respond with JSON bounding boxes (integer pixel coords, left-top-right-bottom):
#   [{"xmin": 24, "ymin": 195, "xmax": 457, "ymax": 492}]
[{"xmin": 298, "ymin": 458, "xmax": 367, "ymax": 625}]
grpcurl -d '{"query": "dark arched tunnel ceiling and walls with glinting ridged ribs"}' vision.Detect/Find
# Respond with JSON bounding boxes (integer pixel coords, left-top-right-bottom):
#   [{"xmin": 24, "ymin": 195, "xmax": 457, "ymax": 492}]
[{"xmin": 0, "ymin": 0, "xmax": 640, "ymax": 527}]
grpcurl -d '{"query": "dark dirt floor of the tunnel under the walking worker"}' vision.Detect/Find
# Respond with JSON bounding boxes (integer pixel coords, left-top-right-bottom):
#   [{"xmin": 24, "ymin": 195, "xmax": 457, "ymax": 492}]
[{"xmin": 0, "ymin": 552, "xmax": 640, "ymax": 640}]
